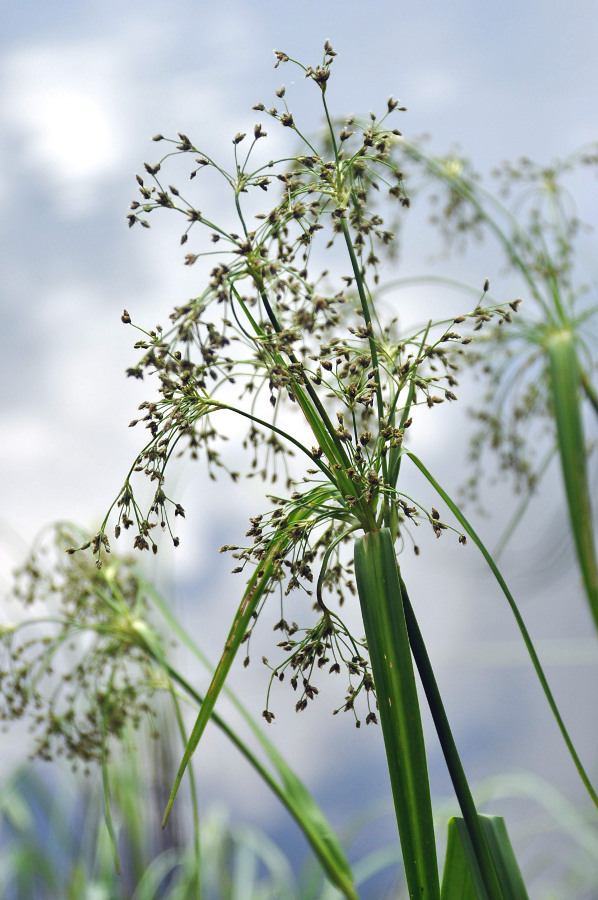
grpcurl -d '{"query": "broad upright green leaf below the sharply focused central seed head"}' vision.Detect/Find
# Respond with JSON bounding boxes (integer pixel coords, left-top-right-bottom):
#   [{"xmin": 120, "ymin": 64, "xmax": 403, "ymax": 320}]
[{"xmin": 355, "ymin": 528, "xmax": 440, "ymax": 900}]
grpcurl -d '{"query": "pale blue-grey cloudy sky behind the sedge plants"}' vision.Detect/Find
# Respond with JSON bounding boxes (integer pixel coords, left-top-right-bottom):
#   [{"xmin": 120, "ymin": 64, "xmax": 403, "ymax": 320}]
[{"xmin": 0, "ymin": 0, "xmax": 598, "ymax": 896}]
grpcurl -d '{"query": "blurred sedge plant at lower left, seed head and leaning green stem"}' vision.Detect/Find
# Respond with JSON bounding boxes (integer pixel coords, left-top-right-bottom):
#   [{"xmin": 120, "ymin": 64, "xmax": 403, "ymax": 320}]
[{"xmin": 0, "ymin": 523, "xmax": 357, "ymax": 900}]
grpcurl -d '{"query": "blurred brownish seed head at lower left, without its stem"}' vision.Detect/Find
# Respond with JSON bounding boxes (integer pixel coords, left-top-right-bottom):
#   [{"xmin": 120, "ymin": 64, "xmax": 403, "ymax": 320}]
[{"xmin": 0, "ymin": 525, "xmax": 164, "ymax": 769}]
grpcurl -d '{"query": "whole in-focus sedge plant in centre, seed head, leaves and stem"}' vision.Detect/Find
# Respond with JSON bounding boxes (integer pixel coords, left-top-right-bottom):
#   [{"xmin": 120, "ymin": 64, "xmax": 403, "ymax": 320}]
[{"xmin": 5, "ymin": 42, "xmax": 598, "ymax": 900}]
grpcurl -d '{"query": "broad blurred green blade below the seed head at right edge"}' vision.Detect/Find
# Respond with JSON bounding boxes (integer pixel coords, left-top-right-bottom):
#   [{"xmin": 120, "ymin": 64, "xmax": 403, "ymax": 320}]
[{"xmin": 546, "ymin": 330, "xmax": 598, "ymax": 628}]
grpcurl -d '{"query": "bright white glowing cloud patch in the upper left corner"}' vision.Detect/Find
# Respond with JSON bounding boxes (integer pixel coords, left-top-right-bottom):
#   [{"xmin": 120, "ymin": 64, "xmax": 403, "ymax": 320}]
[{"xmin": 0, "ymin": 8, "xmax": 268, "ymax": 217}]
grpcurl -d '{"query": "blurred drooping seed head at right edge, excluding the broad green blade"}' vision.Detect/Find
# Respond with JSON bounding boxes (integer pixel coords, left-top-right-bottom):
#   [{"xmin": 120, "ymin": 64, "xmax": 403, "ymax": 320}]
[{"xmin": 391, "ymin": 141, "xmax": 598, "ymax": 500}]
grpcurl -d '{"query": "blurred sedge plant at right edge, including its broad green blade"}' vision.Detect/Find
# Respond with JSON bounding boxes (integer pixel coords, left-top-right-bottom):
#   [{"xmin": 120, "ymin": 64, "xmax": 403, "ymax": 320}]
[{"xmin": 385, "ymin": 140, "xmax": 598, "ymax": 628}]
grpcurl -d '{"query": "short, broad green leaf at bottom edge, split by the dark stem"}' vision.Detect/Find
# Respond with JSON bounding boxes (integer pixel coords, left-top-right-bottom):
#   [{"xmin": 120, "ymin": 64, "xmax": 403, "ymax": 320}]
[{"xmin": 441, "ymin": 816, "xmax": 528, "ymax": 900}]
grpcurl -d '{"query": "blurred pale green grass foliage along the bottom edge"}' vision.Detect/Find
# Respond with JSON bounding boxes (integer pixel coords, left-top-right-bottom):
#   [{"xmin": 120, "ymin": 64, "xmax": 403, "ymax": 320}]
[{"xmin": 0, "ymin": 752, "xmax": 598, "ymax": 900}]
